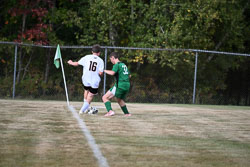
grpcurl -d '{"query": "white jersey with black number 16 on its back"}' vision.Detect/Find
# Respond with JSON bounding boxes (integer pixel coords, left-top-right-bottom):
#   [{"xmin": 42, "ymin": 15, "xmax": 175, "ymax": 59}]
[{"xmin": 78, "ymin": 55, "xmax": 104, "ymax": 88}]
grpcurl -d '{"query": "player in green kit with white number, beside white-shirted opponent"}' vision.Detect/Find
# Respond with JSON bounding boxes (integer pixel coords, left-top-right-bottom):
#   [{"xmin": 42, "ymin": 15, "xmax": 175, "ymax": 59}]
[{"xmin": 102, "ymin": 52, "xmax": 131, "ymax": 116}]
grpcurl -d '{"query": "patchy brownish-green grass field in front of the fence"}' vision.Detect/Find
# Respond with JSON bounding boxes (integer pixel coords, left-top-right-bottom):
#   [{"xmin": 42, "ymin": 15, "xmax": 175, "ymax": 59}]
[{"xmin": 0, "ymin": 100, "xmax": 250, "ymax": 167}]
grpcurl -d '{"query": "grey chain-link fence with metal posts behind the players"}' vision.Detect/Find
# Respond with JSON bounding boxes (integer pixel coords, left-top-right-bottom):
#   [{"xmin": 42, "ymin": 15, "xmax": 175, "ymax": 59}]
[{"xmin": 0, "ymin": 42, "xmax": 250, "ymax": 105}]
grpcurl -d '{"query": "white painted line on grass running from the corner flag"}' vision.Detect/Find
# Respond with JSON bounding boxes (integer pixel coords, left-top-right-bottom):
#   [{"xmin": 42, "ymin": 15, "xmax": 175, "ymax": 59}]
[{"xmin": 68, "ymin": 105, "xmax": 109, "ymax": 167}]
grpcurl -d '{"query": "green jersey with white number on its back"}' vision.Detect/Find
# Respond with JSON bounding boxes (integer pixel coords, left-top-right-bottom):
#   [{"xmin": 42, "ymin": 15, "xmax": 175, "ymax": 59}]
[{"xmin": 112, "ymin": 62, "xmax": 130, "ymax": 90}]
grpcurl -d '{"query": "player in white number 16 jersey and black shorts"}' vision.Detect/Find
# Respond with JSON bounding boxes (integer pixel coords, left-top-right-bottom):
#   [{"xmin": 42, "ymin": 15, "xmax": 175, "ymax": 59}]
[{"xmin": 68, "ymin": 45, "xmax": 104, "ymax": 114}]
